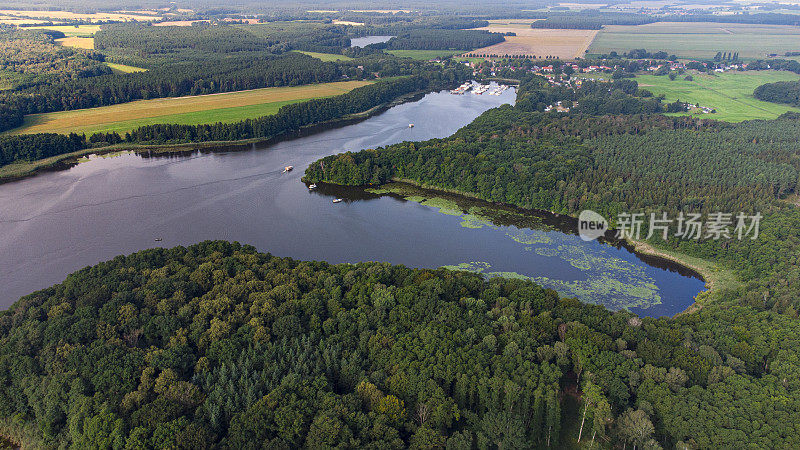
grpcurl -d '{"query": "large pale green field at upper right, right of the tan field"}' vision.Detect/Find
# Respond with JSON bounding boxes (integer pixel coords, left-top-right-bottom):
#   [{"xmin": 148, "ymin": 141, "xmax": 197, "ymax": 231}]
[{"xmin": 589, "ymin": 22, "xmax": 800, "ymax": 59}]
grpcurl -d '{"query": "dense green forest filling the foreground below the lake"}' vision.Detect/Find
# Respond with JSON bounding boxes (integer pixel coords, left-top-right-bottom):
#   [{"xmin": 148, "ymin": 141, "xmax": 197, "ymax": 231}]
[{"xmin": 0, "ymin": 242, "xmax": 800, "ymax": 449}]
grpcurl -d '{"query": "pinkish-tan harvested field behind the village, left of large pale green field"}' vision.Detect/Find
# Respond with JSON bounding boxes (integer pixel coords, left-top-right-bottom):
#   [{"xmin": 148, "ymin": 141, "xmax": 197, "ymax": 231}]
[{"xmin": 469, "ymin": 25, "xmax": 597, "ymax": 59}]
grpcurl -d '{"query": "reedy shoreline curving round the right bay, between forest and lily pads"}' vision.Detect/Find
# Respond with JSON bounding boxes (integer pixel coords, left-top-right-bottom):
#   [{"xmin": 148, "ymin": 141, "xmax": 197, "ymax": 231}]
[{"xmin": 384, "ymin": 177, "xmax": 741, "ymax": 317}]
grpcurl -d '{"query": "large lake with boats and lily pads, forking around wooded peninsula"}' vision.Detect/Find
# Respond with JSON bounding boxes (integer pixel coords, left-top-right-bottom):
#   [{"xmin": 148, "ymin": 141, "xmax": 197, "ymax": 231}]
[{"xmin": 0, "ymin": 89, "xmax": 703, "ymax": 316}]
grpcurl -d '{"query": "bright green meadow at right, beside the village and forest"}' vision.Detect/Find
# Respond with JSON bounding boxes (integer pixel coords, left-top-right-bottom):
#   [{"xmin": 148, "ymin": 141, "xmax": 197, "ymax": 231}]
[{"xmin": 635, "ymin": 70, "xmax": 800, "ymax": 122}]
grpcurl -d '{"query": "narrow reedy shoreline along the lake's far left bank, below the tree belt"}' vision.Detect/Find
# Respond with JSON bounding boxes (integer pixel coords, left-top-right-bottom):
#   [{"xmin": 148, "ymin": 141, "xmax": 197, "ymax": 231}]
[{"xmin": 0, "ymin": 89, "xmax": 432, "ymax": 184}]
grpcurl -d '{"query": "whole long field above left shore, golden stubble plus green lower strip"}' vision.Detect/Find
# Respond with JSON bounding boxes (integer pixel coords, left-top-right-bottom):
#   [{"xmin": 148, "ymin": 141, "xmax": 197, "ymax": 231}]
[{"xmin": 10, "ymin": 81, "xmax": 369, "ymax": 134}]
